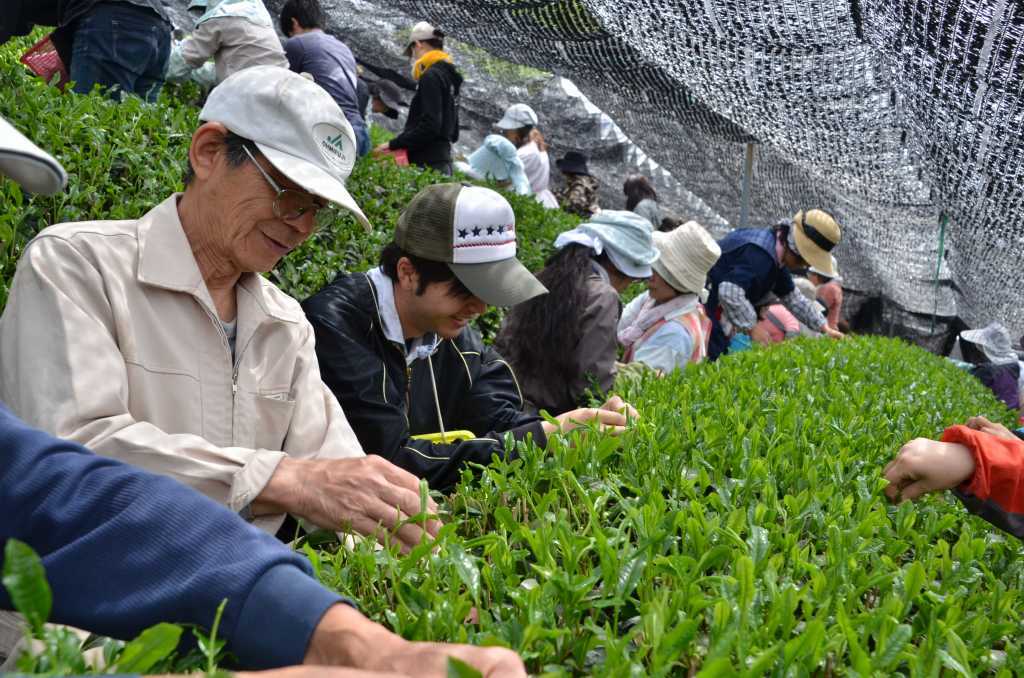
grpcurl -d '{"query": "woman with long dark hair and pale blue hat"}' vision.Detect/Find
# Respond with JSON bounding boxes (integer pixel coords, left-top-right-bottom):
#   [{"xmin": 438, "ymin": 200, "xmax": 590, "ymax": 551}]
[{"xmin": 496, "ymin": 211, "xmax": 658, "ymax": 413}]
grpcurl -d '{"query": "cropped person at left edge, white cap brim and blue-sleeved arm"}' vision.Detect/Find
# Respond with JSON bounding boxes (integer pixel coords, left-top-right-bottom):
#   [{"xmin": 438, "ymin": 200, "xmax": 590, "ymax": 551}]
[{"xmin": 0, "ymin": 118, "xmax": 526, "ymax": 678}]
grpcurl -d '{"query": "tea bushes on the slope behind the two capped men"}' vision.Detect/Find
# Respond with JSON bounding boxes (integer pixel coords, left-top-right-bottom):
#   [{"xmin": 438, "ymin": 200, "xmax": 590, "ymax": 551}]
[{"xmin": 0, "ymin": 32, "xmax": 579, "ymax": 337}]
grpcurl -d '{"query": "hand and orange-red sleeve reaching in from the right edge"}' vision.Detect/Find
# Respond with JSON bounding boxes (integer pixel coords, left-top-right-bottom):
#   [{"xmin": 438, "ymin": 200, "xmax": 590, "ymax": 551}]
[{"xmin": 884, "ymin": 417, "xmax": 1024, "ymax": 539}]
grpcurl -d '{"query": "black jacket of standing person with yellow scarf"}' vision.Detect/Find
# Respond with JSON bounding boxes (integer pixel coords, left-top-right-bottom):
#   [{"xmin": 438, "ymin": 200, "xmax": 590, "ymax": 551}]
[{"xmin": 388, "ymin": 61, "xmax": 462, "ymax": 165}]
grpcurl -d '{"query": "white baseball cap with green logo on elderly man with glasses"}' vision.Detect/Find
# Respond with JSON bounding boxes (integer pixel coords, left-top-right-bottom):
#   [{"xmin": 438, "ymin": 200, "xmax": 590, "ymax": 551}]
[{"xmin": 199, "ymin": 66, "xmax": 370, "ymax": 229}]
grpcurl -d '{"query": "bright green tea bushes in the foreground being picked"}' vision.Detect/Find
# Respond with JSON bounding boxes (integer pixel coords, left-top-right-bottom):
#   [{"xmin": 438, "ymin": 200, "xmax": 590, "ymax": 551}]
[{"xmin": 309, "ymin": 339, "xmax": 1024, "ymax": 676}]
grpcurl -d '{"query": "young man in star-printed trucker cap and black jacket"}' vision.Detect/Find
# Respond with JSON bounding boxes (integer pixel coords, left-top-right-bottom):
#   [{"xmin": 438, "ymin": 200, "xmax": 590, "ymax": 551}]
[{"xmin": 303, "ymin": 183, "xmax": 636, "ymax": 491}]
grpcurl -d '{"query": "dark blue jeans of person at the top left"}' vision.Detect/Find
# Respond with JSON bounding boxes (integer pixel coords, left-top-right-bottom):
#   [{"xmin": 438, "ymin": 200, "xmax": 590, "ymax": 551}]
[{"xmin": 71, "ymin": 2, "xmax": 171, "ymax": 101}]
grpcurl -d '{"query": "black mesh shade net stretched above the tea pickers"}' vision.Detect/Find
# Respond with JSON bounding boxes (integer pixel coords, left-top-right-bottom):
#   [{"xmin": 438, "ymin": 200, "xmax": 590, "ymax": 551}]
[{"xmin": 169, "ymin": 0, "xmax": 1024, "ymax": 348}]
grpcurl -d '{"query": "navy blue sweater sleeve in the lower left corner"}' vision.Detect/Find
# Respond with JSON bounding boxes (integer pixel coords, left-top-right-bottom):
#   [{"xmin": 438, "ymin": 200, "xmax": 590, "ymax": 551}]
[{"xmin": 0, "ymin": 405, "xmax": 342, "ymax": 669}]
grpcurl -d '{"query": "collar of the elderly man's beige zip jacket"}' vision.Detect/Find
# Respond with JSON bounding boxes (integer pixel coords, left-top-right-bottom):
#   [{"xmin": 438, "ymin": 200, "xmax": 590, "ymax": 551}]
[{"xmin": 136, "ymin": 194, "xmax": 300, "ymax": 323}]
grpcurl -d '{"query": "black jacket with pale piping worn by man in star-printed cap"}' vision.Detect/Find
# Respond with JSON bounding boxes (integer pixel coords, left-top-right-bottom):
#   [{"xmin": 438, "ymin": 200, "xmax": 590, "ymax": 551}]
[{"xmin": 302, "ymin": 273, "xmax": 547, "ymax": 491}]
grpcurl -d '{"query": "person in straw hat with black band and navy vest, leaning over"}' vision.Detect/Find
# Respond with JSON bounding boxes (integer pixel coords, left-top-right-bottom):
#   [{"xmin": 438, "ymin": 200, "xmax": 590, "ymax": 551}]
[{"xmin": 706, "ymin": 210, "xmax": 843, "ymax": 361}]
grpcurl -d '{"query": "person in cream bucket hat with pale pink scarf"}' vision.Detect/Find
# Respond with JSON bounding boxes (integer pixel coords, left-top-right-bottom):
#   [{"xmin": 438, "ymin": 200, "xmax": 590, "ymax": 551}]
[{"xmin": 618, "ymin": 221, "xmax": 722, "ymax": 374}]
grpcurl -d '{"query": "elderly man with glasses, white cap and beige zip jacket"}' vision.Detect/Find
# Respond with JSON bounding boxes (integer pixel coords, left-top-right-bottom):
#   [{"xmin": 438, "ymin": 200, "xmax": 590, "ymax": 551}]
[{"xmin": 0, "ymin": 67, "xmax": 438, "ymax": 548}]
